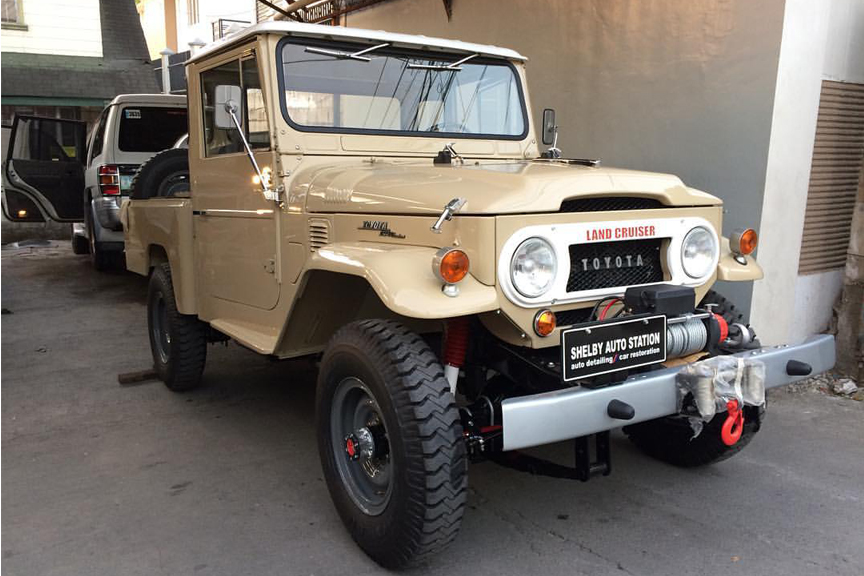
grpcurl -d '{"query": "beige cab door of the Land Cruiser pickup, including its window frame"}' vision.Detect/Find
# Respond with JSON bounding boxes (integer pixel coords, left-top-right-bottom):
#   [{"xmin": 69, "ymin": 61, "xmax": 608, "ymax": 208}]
[{"xmin": 189, "ymin": 48, "xmax": 279, "ymax": 314}]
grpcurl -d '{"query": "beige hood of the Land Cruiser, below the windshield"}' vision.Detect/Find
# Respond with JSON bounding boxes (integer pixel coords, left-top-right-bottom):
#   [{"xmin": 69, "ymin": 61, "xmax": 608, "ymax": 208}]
[{"xmin": 295, "ymin": 159, "xmax": 721, "ymax": 215}]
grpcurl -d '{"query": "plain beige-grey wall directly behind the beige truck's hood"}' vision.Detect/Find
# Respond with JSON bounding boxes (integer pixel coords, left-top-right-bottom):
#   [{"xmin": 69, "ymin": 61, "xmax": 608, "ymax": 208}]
[{"xmin": 347, "ymin": 0, "xmax": 784, "ymax": 316}]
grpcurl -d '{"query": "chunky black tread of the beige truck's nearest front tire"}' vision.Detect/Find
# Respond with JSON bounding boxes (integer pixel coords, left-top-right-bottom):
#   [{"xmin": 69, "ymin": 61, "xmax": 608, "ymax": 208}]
[{"xmin": 319, "ymin": 320, "xmax": 468, "ymax": 569}]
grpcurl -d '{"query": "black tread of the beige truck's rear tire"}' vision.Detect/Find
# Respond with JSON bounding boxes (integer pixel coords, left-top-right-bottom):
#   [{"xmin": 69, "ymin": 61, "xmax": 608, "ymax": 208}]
[{"xmin": 148, "ymin": 262, "xmax": 207, "ymax": 392}]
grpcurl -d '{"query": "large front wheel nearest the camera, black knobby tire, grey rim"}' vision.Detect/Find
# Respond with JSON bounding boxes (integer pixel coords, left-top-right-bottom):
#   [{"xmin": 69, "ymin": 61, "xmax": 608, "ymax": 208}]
[{"xmin": 316, "ymin": 320, "xmax": 468, "ymax": 569}]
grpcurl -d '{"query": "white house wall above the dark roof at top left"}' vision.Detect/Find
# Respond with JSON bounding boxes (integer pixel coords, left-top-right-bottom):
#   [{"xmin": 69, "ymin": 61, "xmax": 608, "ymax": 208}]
[{"xmin": 0, "ymin": 0, "xmax": 102, "ymax": 57}]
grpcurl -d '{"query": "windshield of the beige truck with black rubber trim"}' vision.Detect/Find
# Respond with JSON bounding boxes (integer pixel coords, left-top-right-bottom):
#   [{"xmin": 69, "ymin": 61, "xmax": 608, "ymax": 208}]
[{"xmin": 281, "ymin": 42, "xmax": 527, "ymax": 140}]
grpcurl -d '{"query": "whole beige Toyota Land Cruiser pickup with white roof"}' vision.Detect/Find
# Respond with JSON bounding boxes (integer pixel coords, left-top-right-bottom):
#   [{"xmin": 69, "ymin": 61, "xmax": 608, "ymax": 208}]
[{"xmin": 11, "ymin": 23, "xmax": 834, "ymax": 568}]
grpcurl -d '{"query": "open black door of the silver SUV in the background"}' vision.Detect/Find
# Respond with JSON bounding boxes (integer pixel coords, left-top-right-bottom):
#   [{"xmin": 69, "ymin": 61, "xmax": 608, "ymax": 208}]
[{"xmin": 3, "ymin": 116, "xmax": 86, "ymax": 222}]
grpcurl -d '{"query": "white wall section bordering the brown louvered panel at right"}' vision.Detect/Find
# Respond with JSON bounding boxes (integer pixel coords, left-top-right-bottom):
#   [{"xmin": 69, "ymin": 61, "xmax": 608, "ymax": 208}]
[{"xmin": 751, "ymin": 0, "xmax": 864, "ymax": 344}]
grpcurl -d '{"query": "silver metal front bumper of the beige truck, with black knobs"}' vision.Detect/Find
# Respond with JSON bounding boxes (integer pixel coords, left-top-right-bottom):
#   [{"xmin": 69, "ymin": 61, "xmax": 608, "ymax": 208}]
[{"xmin": 501, "ymin": 335, "xmax": 835, "ymax": 450}]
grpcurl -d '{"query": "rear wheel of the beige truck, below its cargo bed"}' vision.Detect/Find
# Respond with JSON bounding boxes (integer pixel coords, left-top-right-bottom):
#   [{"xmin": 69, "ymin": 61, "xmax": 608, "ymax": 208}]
[{"xmin": 147, "ymin": 262, "xmax": 208, "ymax": 392}]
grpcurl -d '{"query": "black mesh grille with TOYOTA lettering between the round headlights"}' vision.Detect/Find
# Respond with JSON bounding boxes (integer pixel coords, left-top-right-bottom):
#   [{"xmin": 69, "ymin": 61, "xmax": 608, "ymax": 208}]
[{"xmin": 567, "ymin": 238, "xmax": 664, "ymax": 292}]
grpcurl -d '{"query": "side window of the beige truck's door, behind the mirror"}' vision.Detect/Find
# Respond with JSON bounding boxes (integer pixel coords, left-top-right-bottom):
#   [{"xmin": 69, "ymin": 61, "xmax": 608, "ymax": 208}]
[{"xmin": 201, "ymin": 56, "xmax": 270, "ymax": 157}]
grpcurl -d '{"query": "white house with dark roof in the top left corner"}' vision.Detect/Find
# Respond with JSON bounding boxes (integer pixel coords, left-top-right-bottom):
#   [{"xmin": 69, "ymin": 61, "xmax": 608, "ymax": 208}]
[{"xmin": 2, "ymin": 0, "xmax": 156, "ymax": 124}]
